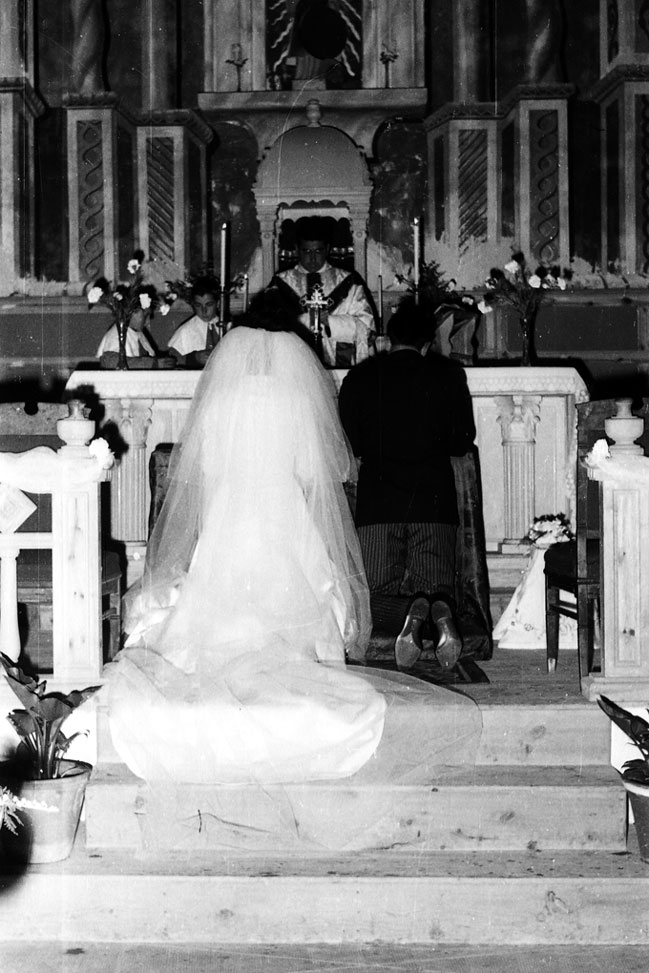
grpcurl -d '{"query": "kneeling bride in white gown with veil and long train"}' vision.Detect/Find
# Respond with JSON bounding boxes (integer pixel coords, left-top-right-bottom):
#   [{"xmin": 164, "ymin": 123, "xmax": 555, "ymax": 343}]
[{"xmin": 107, "ymin": 299, "xmax": 480, "ymax": 844}]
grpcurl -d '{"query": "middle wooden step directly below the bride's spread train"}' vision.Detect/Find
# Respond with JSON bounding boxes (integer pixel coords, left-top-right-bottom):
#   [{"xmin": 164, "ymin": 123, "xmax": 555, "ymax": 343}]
[{"xmin": 86, "ymin": 766, "xmax": 626, "ymax": 855}]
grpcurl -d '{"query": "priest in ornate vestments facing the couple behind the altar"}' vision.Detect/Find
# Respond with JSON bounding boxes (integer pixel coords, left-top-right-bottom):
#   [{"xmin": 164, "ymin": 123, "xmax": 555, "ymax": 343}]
[{"xmin": 269, "ymin": 216, "xmax": 374, "ymax": 368}]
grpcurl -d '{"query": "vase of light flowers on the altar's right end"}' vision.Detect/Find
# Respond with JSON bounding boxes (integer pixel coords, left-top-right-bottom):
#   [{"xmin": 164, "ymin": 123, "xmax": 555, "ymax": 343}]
[{"xmin": 481, "ymin": 252, "xmax": 572, "ymax": 365}]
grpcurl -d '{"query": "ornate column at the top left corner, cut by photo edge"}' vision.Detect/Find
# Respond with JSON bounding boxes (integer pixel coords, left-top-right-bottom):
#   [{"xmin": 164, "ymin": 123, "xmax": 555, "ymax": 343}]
[{"xmin": 0, "ymin": 0, "xmax": 45, "ymax": 294}]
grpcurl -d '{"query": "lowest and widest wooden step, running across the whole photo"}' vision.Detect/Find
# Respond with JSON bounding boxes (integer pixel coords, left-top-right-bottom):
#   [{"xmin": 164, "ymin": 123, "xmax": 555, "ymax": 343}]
[{"xmin": 2, "ymin": 851, "xmax": 649, "ymax": 940}]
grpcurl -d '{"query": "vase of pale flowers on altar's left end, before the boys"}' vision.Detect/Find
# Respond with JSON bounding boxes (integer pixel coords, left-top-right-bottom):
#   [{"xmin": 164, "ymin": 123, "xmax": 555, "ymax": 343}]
[{"xmin": 87, "ymin": 250, "xmax": 178, "ymax": 369}]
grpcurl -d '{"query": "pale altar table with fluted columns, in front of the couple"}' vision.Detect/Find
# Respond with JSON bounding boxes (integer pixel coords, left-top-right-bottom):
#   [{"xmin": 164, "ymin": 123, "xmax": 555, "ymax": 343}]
[{"xmin": 66, "ymin": 366, "xmax": 588, "ymax": 584}]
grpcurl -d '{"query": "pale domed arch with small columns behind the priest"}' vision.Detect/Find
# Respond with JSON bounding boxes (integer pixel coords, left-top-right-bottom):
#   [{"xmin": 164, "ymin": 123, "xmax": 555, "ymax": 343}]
[{"xmin": 255, "ymin": 114, "xmax": 372, "ymax": 281}]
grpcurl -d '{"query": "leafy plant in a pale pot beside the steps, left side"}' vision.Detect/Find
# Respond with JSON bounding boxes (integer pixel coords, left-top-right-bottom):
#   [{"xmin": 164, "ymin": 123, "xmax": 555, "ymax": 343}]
[{"xmin": 0, "ymin": 653, "xmax": 99, "ymax": 863}]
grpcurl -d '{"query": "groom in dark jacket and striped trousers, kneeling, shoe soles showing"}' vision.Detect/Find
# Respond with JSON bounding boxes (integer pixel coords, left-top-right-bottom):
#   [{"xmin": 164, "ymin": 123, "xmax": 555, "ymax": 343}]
[{"xmin": 339, "ymin": 298, "xmax": 475, "ymax": 669}]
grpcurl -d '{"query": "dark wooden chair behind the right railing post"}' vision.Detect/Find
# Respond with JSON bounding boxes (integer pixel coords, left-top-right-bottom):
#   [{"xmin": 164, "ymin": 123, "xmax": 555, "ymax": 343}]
[{"xmin": 545, "ymin": 399, "xmax": 649, "ymax": 679}]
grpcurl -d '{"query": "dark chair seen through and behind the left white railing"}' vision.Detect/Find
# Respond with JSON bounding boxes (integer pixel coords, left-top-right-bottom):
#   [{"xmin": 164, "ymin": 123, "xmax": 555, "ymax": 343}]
[{"xmin": 0, "ymin": 402, "xmax": 122, "ymax": 671}]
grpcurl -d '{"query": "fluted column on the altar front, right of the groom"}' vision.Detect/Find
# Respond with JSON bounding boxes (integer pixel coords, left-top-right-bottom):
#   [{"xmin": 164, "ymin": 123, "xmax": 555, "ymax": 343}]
[{"xmin": 495, "ymin": 395, "xmax": 541, "ymax": 545}]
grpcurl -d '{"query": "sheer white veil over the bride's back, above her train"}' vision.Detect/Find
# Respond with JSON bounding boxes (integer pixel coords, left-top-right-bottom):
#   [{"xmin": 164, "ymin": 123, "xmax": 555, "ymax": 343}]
[{"xmin": 121, "ymin": 327, "xmax": 371, "ymax": 670}]
